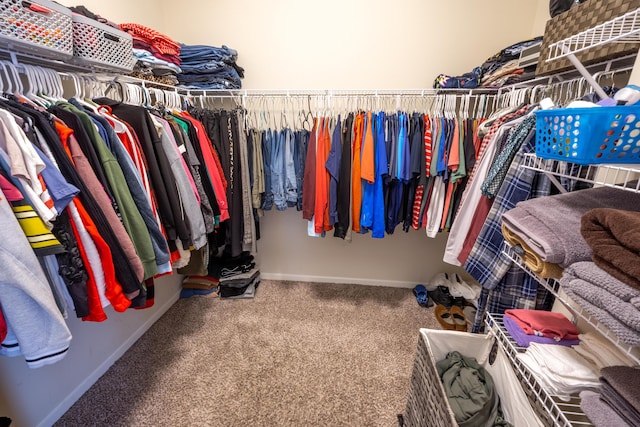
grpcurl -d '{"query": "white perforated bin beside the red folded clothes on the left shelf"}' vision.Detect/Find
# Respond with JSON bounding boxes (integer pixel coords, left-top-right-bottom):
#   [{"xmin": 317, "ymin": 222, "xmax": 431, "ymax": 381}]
[{"xmin": 72, "ymin": 13, "xmax": 135, "ymax": 71}]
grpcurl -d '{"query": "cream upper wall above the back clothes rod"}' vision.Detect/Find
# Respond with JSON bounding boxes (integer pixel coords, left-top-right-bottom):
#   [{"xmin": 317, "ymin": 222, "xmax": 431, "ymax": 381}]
[{"xmin": 164, "ymin": 0, "xmax": 540, "ymax": 89}]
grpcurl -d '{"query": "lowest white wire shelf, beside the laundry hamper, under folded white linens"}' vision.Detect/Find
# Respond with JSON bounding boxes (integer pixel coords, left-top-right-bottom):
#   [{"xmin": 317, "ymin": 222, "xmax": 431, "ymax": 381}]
[{"xmin": 485, "ymin": 313, "xmax": 593, "ymax": 427}]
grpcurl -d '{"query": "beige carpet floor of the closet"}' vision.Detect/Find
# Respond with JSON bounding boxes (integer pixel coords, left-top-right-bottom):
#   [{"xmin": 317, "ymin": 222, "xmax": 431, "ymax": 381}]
[{"xmin": 56, "ymin": 280, "xmax": 440, "ymax": 427}]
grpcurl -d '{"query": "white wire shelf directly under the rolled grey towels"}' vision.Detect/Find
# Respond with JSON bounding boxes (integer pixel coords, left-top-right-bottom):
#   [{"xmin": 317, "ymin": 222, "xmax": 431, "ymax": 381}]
[{"xmin": 502, "ymin": 242, "xmax": 640, "ymax": 365}]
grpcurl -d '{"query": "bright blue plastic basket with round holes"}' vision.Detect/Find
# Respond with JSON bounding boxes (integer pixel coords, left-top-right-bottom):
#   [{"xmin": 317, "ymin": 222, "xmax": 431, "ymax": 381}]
[{"xmin": 536, "ymin": 106, "xmax": 640, "ymax": 165}]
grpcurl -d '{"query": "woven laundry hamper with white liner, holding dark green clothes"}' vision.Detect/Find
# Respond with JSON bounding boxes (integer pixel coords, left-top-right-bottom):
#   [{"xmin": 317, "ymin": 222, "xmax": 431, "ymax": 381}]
[{"xmin": 403, "ymin": 329, "xmax": 544, "ymax": 427}]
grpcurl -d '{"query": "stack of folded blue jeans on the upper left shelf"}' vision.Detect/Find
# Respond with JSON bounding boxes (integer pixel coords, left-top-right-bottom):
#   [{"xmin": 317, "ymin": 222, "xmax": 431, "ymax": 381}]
[{"xmin": 178, "ymin": 44, "xmax": 244, "ymax": 90}]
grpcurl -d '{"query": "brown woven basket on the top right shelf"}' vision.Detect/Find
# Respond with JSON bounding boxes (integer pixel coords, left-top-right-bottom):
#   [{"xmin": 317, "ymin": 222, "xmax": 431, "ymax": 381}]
[{"xmin": 536, "ymin": 0, "xmax": 640, "ymax": 76}]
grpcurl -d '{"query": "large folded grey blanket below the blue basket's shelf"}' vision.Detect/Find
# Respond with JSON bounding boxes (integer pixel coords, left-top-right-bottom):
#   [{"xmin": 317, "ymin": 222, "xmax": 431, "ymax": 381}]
[{"xmin": 502, "ymin": 187, "xmax": 640, "ymax": 268}]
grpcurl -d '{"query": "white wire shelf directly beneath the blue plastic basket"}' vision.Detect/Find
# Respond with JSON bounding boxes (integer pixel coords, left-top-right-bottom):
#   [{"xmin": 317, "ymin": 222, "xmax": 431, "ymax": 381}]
[{"xmin": 522, "ymin": 154, "xmax": 640, "ymax": 193}]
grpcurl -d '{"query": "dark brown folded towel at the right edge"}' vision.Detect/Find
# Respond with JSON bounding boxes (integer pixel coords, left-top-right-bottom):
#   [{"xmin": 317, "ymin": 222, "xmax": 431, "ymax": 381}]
[{"xmin": 580, "ymin": 208, "xmax": 640, "ymax": 289}]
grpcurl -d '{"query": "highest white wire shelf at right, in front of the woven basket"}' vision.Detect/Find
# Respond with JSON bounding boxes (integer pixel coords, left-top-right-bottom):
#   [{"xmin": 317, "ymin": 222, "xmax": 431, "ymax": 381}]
[{"xmin": 547, "ymin": 8, "xmax": 640, "ymax": 61}]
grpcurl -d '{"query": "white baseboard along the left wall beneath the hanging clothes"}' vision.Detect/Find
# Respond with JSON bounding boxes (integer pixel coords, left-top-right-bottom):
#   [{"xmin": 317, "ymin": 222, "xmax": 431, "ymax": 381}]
[{"xmin": 38, "ymin": 289, "xmax": 180, "ymax": 427}]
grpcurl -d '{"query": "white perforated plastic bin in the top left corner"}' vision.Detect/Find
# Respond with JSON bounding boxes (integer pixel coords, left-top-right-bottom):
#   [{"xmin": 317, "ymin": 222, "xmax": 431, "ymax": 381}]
[{"xmin": 0, "ymin": 0, "xmax": 73, "ymax": 60}]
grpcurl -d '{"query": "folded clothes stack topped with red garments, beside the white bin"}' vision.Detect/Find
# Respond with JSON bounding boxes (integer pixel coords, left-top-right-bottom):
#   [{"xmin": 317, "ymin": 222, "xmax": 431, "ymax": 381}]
[{"xmin": 120, "ymin": 23, "xmax": 181, "ymax": 85}]
